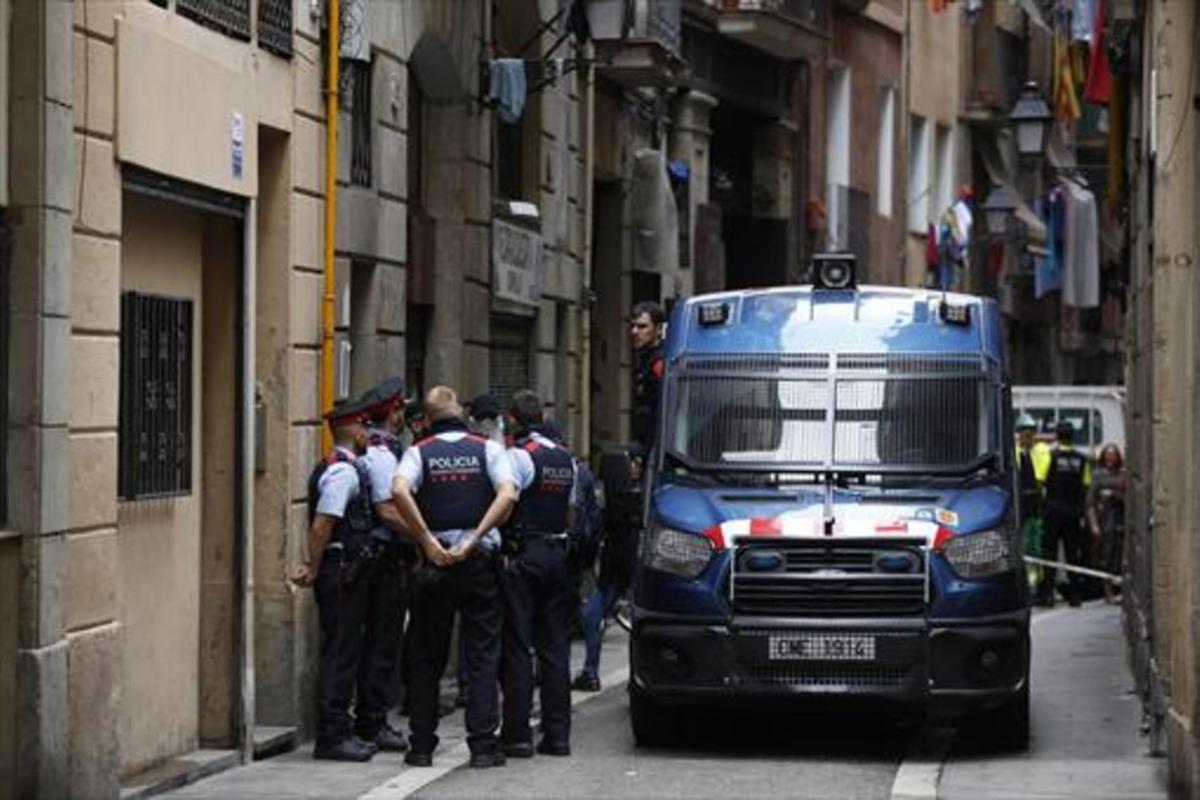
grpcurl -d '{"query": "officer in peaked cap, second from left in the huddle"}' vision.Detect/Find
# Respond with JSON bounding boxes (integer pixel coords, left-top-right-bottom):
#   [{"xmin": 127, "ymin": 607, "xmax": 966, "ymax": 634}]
[{"xmin": 355, "ymin": 378, "xmax": 413, "ymax": 752}]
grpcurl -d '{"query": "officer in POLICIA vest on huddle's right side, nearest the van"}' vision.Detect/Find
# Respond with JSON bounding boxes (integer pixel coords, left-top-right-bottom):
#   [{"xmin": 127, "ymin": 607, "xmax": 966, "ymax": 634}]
[{"xmin": 500, "ymin": 390, "xmax": 576, "ymax": 758}]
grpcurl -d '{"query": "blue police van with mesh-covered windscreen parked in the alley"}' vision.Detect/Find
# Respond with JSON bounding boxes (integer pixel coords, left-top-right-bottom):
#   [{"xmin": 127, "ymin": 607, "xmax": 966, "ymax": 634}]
[{"xmin": 629, "ymin": 255, "xmax": 1030, "ymax": 747}]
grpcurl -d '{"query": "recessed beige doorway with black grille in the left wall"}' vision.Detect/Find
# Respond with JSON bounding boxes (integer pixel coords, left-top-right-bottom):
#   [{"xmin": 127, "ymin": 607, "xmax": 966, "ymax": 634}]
[{"xmin": 118, "ymin": 190, "xmax": 242, "ymax": 777}]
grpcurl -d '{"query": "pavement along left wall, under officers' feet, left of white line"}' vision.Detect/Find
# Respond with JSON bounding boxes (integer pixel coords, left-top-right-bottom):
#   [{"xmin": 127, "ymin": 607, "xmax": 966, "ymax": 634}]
[{"xmin": 160, "ymin": 624, "xmax": 628, "ymax": 800}]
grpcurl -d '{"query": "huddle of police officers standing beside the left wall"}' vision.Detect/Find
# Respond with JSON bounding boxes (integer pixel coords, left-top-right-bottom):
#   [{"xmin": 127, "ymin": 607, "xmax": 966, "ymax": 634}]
[{"xmin": 292, "ymin": 379, "xmax": 580, "ymax": 768}]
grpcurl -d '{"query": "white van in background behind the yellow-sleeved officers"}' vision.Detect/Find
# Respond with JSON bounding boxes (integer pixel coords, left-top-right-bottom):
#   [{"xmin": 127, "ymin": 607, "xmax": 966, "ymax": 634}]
[{"xmin": 1013, "ymin": 386, "xmax": 1126, "ymax": 456}]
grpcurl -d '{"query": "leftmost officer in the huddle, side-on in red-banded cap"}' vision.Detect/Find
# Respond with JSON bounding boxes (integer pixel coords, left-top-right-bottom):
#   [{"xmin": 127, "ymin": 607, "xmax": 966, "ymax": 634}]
[{"xmin": 292, "ymin": 403, "xmax": 376, "ymax": 762}]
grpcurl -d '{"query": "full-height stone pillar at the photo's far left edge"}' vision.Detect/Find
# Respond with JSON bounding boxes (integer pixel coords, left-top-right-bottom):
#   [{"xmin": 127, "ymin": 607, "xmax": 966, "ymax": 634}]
[{"xmin": 5, "ymin": 2, "xmax": 74, "ymax": 798}]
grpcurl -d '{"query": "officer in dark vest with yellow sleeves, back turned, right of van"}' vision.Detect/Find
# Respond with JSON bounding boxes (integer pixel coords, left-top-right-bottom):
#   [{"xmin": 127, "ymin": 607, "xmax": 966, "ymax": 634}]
[{"xmin": 1038, "ymin": 421, "xmax": 1091, "ymax": 607}]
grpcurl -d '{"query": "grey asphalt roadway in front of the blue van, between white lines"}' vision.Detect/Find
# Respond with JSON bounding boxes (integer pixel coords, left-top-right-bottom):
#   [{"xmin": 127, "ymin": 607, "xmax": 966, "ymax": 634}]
[{"xmin": 415, "ymin": 687, "xmax": 914, "ymax": 798}]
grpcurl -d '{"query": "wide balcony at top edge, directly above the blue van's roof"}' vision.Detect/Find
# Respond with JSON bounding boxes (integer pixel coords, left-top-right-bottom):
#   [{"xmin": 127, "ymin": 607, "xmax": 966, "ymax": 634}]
[{"xmin": 704, "ymin": 0, "xmax": 832, "ymax": 60}]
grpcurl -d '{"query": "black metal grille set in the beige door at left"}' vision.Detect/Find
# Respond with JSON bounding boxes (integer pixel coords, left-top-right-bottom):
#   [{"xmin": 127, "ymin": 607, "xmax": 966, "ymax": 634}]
[{"xmin": 118, "ymin": 291, "xmax": 193, "ymax": 500}]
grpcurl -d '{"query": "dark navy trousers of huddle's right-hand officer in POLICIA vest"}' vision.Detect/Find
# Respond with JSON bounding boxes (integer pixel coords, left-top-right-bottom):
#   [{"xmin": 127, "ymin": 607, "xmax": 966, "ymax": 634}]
[{"xmin": 502, "ymin": 536, "xmax": 571, "ymax": 745}]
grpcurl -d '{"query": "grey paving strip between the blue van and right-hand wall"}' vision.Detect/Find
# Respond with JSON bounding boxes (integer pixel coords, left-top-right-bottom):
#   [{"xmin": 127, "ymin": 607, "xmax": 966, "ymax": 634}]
[{"xmin": 937, "ymin": 602, "xmax": 1166, "ymax": 800}]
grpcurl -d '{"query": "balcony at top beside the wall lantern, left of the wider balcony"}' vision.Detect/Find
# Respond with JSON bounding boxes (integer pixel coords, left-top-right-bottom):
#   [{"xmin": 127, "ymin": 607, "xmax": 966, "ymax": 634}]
[{"xmin": 587, "ymin": 0, "xmax": 684, "ymax": 88}]
